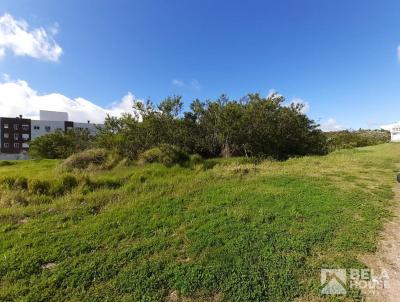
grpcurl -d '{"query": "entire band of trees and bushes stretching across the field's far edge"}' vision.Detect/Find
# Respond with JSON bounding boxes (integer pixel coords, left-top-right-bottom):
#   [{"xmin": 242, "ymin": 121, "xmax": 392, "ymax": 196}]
[{"xmin": 30, "ymin": 94, "xmax": 390, "ymax": 165}]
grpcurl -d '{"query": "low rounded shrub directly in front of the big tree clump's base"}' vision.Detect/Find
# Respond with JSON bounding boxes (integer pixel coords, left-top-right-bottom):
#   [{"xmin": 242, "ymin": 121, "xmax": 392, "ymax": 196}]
[{"xmin": 139, "ymin": 144, "xmax": 189, "ymax": 167}]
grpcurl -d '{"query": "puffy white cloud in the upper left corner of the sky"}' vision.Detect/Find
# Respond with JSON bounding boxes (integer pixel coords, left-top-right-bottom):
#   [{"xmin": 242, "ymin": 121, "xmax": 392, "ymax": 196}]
[{"xmin": 0, "ymin": 14, "xmax": 62, "ymax": 61}]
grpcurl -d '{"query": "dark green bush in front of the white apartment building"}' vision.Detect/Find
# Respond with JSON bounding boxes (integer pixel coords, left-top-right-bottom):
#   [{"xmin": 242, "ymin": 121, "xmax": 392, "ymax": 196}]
[{"xmin": 29, "ymin": 129, "xmax": 93, "ymax": 159}]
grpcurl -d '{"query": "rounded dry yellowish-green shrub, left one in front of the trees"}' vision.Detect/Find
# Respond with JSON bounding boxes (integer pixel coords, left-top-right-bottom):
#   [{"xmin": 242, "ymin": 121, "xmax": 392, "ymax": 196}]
[{"xmin": 61, "ymin": 149, "xmax": 117, "ymax": 171}]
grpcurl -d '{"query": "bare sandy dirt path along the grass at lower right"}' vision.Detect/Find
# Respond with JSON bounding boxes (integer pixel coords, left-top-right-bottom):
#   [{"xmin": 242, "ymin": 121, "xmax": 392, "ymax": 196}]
[{"xmin": 361, "ymin": 178, "xmax": 400, "ymax": 302}]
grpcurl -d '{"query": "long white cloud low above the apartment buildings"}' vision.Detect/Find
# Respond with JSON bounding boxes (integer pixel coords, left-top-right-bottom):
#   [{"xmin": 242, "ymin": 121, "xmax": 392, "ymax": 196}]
[{"xmin": 0, "ymin": 75, "xmax": 135, "ymax": 123}]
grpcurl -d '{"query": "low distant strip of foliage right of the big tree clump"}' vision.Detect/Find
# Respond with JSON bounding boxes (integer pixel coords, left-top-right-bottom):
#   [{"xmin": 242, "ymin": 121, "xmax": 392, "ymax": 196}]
[{"xmin": 326, "ymin": 129, "xmax": 390, "ymax": 151}]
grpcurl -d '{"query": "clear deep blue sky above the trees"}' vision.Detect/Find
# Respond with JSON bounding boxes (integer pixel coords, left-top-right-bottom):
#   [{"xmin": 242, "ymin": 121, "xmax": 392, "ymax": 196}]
[{"xmin": 0, "ymin": 0, "xmax": 400, "ymax": 128}]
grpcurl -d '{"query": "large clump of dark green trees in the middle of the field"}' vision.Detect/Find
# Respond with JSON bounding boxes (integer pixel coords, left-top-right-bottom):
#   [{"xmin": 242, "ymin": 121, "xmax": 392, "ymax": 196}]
[{"xmin": 96, "ymin": 94, "xmax": 327, "ymax": 159}]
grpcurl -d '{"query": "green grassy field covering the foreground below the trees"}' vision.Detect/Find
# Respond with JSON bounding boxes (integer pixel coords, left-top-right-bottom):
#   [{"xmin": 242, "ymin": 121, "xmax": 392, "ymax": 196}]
[{"xmin": 0, "ymin": 144, "xmax": 400, "ymax": 301}]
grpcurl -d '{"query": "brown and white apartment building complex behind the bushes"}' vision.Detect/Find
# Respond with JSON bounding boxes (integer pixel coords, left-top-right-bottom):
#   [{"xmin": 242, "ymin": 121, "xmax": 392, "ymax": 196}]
[{"xmin": 0, "ymin": 110, "xmax": 101, "ymax": 154}]
